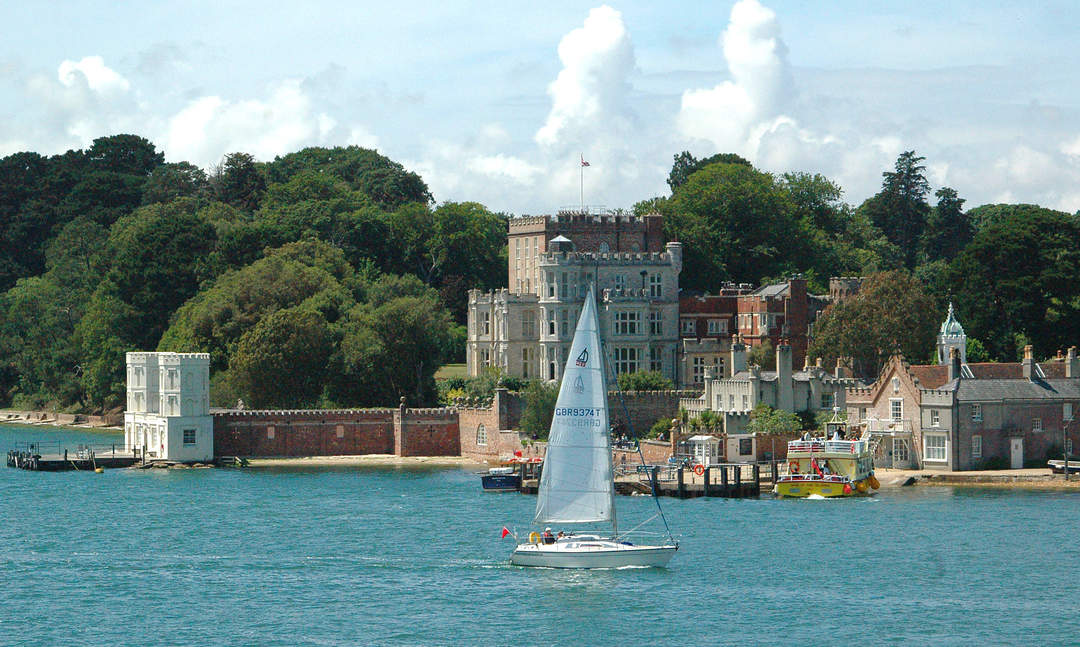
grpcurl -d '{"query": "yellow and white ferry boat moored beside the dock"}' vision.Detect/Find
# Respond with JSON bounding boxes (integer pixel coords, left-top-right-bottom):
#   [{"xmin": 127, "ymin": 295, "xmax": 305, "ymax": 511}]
[{"xmin": 774, "ymin": 421, "xmax": 880, "ymax": 497}]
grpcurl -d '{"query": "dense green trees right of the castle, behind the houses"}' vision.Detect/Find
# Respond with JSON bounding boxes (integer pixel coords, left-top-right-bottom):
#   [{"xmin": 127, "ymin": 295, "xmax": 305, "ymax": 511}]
[{"xmin": 635, "ymin": 151, "xmax": 1080, "ymax": 377}]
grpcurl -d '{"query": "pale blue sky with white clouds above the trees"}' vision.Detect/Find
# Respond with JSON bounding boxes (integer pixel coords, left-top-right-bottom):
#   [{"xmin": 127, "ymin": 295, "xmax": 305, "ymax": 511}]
[{"xmin": 0, "ymin": 0, "xmax": 1080, "ymax": 215}]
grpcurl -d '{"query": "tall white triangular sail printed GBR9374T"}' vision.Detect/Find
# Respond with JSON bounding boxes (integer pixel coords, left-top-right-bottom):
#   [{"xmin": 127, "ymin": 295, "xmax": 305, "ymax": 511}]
[{"xmin": 536, "ymin": 288, "xmax": 616, "ymax": 526}]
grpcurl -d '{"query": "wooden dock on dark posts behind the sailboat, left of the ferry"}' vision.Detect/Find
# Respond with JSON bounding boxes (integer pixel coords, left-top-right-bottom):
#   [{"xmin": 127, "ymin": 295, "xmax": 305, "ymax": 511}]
[{"xmin": 521, "ymin": 463, "xmax": 779, "ymax": 499}]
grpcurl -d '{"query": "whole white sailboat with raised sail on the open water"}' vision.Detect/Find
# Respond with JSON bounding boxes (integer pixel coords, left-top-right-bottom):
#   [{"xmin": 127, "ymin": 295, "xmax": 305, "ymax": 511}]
[{"xmin": 510, "ymin": 287, "xmax": 678, "ymax": 568}]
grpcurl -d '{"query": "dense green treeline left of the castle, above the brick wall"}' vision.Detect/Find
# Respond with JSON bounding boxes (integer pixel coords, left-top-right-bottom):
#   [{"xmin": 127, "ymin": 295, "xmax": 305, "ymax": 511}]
[{"xmin": 0, "ymin": 135, "xmax": 505, "ymax": 409}]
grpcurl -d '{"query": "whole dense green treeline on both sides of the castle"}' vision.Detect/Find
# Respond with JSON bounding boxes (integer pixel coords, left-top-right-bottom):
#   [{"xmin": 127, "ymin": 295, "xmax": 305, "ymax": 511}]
[{"xmin": 0, "ymin": 135, "xmax": 1080, "ymax": 410}]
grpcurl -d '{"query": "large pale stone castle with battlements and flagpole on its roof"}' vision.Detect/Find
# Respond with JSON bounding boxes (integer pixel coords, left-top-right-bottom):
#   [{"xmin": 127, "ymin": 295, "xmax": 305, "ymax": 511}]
[{"xmin": 465, "ymin": 212, "xmax": 683, "ymax": 380}]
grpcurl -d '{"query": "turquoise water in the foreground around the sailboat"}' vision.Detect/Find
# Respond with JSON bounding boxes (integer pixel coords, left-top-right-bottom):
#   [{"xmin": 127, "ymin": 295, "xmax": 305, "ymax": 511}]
[{"xmin": 0, "ymin": 427, "xmax": 1080, "ymax": 646}]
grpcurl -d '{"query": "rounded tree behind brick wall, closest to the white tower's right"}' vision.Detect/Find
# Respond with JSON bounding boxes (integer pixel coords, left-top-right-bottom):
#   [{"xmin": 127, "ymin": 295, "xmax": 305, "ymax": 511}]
[{"xmin": 229, "ymin": 308, "xmax": 334, "ymax": 407}]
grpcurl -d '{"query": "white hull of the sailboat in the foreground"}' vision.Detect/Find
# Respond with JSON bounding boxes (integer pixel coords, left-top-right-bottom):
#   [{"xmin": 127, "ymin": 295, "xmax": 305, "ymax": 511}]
[{"xmin": 510, "ymin": 541, "xmax": 678, "ymax": 568}]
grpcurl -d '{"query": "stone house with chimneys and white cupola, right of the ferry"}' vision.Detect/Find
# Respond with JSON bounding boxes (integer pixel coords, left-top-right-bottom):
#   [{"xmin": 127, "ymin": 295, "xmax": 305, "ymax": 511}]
[{"xmin": 847, "ymin": 307, "xmax": 1080, "ymax": 471}]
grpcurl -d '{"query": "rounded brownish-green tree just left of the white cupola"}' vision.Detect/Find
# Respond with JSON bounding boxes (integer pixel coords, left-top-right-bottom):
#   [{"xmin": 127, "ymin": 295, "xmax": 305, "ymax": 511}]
[{"xmin": 809, "ymin": 270, "xmax": 941, "ymax": 378}]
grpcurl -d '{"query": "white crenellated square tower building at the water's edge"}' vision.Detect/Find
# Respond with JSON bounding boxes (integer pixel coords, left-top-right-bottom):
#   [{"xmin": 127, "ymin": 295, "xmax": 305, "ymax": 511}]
[{"xmin": 124, "ymin": 352, "xmax": 214, "ymax": 462}]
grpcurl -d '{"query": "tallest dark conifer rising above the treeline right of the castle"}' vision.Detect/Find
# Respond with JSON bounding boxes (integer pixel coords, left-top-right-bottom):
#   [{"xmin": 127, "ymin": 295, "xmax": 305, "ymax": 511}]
[{"xmin": 859, "ymin": 150, "xmax": 930, "ymax": 270}]
